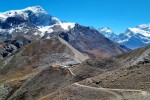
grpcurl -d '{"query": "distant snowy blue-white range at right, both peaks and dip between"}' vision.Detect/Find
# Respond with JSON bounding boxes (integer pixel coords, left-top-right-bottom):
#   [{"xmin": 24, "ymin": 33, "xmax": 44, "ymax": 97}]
[{"xmin": 98, "ymin": 24, "xmax": 150, "ymax": 49}]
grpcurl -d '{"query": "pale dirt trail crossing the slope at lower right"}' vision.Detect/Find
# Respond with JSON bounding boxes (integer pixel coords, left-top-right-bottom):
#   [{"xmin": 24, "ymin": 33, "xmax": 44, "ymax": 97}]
[{"xmin": 74, "ymin": 83, "xmax": 150, "ymax": 100}]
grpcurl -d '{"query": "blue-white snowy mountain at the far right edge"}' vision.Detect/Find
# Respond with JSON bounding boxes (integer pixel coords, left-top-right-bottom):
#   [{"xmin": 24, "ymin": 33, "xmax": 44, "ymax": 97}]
[{"xmin": 115, "ymin": 24, "xmax": 150, "ymax": 49}]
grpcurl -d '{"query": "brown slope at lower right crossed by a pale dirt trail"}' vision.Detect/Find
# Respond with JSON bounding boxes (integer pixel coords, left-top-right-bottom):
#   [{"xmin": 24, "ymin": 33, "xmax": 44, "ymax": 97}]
[{"xmin": 40, "ymin": 47, "xmax": 150, "ymax": 100}]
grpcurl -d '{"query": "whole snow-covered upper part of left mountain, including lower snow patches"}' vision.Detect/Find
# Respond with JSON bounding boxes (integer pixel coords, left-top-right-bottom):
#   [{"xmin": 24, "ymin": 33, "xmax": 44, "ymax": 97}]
[{"xmin": 0, "ymin": 6, "xmax": 75, "ymax": 40}]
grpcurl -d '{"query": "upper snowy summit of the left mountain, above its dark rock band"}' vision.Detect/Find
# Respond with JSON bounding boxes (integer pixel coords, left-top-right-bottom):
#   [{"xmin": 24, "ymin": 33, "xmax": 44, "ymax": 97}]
[{"xmin": 0, "ymin": 6, "xmax": 61, "ymax": 26}]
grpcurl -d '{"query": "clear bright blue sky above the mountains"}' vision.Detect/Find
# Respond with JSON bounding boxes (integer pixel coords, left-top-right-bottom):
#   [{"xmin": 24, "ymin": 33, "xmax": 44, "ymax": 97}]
[{"xmin": 0, "ymin": 0, "xmax": 150, "ymax": 34}]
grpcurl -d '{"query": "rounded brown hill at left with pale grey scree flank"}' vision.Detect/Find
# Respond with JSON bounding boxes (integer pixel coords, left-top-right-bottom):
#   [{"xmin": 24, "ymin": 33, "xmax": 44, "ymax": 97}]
[{"xmin": 0, "ymin": 38, "xmax": 88, "ymax": 100}]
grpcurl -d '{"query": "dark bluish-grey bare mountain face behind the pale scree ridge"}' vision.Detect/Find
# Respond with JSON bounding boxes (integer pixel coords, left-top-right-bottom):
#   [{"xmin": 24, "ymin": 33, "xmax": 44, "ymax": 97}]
[{"xmin": 60, "ymin": 24, "xmax": 124, "ymax": 58}]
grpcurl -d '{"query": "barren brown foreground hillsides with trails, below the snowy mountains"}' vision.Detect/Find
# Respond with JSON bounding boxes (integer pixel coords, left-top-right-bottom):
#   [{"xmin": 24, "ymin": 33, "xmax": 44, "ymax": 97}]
[{"xmin": 0, "ymin": 44, "xmax": 150, "ymax": 100}]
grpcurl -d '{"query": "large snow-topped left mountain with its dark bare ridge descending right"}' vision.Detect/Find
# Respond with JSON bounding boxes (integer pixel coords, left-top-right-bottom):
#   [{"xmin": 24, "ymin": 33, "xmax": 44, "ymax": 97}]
[{"xmin": 0, "ymin": 6, "xmax": 127, "ymax": 58}]
